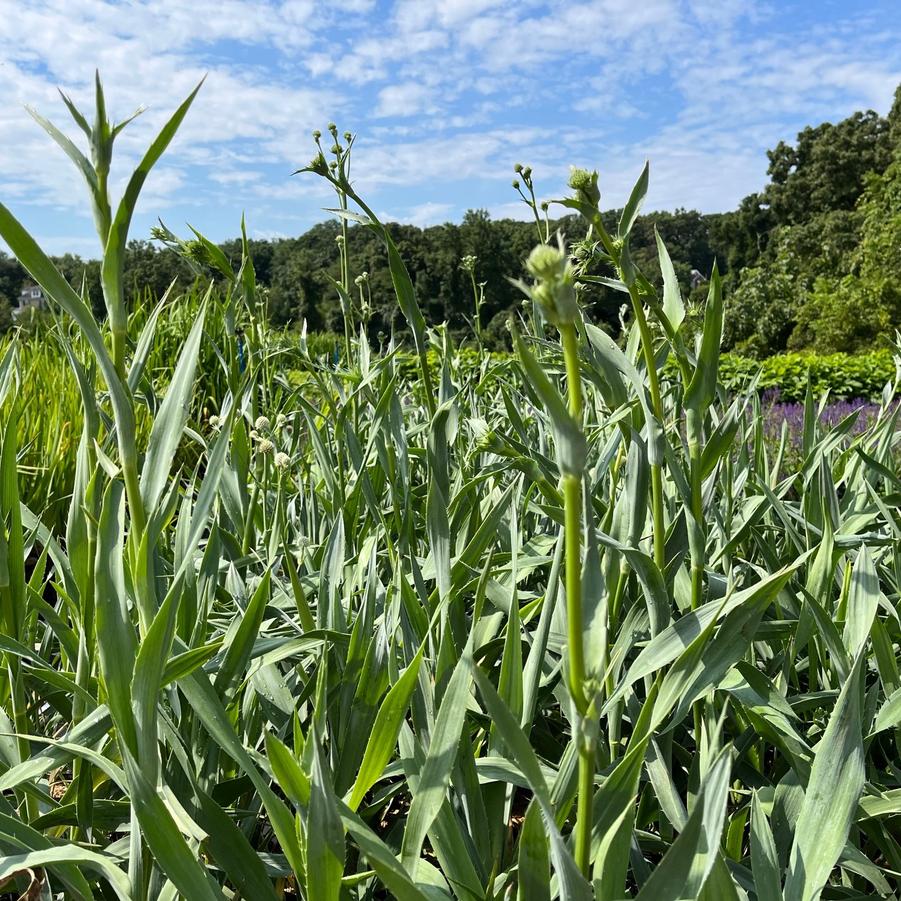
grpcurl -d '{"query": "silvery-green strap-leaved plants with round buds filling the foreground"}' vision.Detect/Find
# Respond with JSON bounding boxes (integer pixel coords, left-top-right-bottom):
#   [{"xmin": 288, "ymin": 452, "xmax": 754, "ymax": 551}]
[{"xmin": 0, "ymin": 75, "xmax": 901, "ymax": 901}]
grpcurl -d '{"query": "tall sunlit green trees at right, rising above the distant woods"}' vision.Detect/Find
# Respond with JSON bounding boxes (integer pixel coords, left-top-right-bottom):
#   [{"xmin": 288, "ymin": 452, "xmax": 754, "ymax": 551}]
[{"xmin": 726, "ymin": 87, "xmax": 901, "ymax": 356}]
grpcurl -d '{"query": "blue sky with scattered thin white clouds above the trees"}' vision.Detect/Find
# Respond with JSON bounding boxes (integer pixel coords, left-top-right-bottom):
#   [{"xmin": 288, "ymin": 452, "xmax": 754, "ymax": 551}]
[{"xmin": 0, "ymin": 0, "xmax": 901, "ymax": 256}]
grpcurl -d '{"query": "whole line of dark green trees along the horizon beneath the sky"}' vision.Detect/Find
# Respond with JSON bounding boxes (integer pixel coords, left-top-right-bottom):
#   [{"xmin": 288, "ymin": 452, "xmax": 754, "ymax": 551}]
[{"xmin": 0, "ymin": 86, "xmax": 901, "ymax": 357}]
